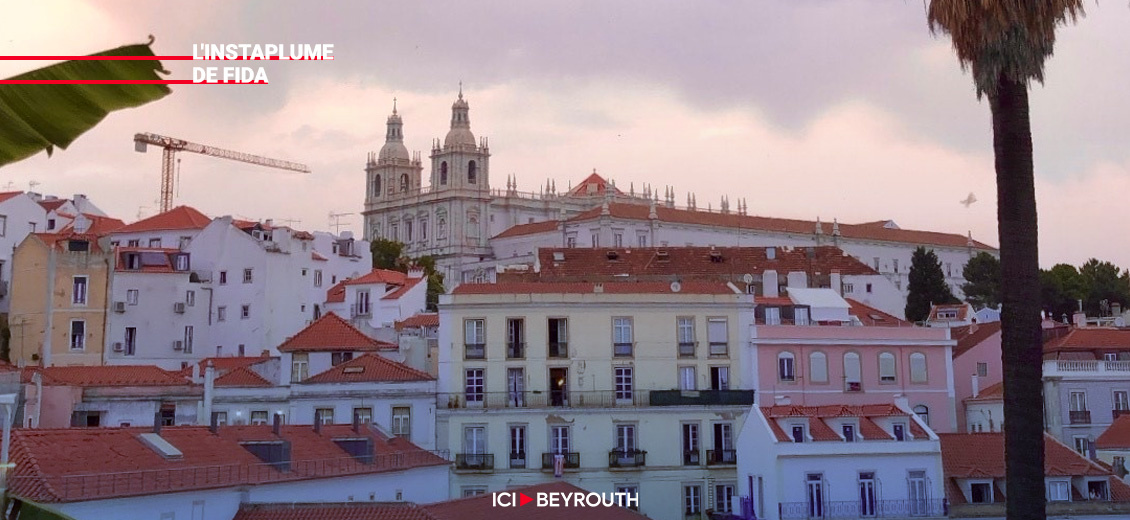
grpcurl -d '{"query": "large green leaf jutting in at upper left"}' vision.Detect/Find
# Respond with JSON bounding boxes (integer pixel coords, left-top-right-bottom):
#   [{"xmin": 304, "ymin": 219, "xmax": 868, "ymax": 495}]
[{"xmin": 0, "ymin": 44, "xmax": 171, "ymax": 166}]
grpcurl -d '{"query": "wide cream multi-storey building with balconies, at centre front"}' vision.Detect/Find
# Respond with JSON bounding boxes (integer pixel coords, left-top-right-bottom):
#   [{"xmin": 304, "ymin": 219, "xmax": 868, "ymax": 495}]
[{"xmin": 436, "ymin": 281, "xmax": 754, "ymax": 520}]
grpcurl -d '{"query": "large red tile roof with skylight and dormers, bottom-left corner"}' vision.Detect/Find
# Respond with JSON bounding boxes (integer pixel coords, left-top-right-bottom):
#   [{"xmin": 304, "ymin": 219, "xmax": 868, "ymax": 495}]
[{"xmin": 8, "ymin": 425, "xmax": 449, "ymax": 503}]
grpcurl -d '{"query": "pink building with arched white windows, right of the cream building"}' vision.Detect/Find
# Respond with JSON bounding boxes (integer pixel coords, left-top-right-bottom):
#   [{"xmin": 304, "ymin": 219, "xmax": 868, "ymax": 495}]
[{"xmin": 750, "ymin": 289, "xmax": 957, "ymax": 432}]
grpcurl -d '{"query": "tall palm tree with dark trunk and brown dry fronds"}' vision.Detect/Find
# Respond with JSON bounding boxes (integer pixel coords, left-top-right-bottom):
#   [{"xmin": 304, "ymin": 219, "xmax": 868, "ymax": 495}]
[{"xmin": 927, "ymin": 0, "xmax": 1083, "ymax": 520}]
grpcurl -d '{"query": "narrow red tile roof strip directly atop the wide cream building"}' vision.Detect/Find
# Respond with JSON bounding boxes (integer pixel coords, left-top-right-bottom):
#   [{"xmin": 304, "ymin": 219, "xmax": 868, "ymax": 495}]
[{"xmin": 451, "ymin": 280, "xmax": 740, "ymax": 295}]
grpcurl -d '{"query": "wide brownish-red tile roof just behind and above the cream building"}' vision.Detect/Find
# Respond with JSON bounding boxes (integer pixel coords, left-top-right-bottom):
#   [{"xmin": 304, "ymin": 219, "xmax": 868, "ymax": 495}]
[{"xmin": 528, "ymin": 245, "xmax": 878, "ymax": 281}]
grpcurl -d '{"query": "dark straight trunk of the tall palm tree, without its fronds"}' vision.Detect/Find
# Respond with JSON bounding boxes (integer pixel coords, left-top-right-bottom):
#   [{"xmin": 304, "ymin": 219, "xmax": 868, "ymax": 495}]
[{"xmin": 989, "ymin": 75, "xmax": 1046, "ymax": 520}]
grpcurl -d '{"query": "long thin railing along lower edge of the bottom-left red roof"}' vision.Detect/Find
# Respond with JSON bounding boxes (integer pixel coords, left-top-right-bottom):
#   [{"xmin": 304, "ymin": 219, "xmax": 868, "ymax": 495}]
[{"xmin": 8, "ymin": 450, "xmax": 447, "ymax": 502}]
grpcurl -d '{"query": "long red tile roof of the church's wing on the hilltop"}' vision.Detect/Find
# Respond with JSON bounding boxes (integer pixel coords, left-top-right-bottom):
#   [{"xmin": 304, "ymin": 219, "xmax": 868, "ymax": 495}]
[{"xmin": 499, "ymin": 202, "xmax": 996, "ymax": 251}]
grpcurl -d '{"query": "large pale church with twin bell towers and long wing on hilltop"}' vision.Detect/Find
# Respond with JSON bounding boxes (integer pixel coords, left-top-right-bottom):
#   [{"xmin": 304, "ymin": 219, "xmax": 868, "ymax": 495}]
[{"xmin": 363, "ymin": 88, "xmax": 998, "ymax": 314}]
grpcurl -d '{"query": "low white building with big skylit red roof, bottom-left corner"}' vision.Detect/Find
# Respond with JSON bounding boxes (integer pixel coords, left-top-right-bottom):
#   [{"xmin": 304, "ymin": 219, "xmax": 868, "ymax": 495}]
[{"xmin": 8, "ymin": 425, "xmax": 449, "ymax": 520}]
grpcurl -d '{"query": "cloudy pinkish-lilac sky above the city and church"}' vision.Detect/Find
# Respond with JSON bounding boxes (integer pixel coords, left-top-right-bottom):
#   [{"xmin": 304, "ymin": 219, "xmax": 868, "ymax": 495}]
[{"xmin": 0, "ymin": 0, "xmax": 1130, "ymax": 267}]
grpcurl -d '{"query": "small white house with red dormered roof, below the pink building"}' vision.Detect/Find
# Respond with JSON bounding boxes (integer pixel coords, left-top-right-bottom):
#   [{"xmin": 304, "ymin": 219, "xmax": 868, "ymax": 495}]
[{"xmin": 735, "ymin": 404, "xmax": 946, "ymax": 520}]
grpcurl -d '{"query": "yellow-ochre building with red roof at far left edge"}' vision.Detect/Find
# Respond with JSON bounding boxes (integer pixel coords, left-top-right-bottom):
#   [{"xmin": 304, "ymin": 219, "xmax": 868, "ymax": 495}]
[{"xmin": 9, "ymin": 229, "xmax": 113, "ymax": 366}]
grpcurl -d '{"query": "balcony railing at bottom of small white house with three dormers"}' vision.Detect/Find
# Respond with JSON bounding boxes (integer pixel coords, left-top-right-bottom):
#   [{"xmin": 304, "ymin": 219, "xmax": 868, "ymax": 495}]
[{"xmin": 777, "ymin": 499, "xmax": 948, "ymax": 520}]
